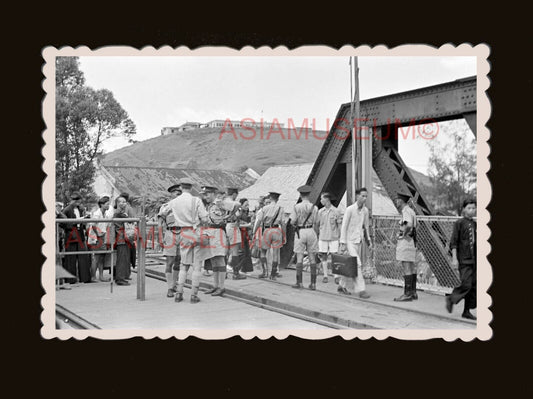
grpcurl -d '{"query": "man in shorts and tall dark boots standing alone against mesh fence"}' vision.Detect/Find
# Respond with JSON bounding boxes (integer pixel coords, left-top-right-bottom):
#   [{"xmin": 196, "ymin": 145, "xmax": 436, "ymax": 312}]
[{"xmin": 394, "ymin": 193, "xmax": 418, "ymax": 302}]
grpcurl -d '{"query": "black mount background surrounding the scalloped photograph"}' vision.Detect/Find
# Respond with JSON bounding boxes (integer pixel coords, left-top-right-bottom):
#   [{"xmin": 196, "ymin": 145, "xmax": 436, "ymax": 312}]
[{"xmin": 8, "ymin": 14, "xmax": 531, "ymax": 397}]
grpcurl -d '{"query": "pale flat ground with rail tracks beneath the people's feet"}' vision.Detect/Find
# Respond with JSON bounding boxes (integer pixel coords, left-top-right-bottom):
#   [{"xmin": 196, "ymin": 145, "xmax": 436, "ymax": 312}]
[{"xmin": 56, "ymin": 264, "xmax": 476, "ymax": 329}]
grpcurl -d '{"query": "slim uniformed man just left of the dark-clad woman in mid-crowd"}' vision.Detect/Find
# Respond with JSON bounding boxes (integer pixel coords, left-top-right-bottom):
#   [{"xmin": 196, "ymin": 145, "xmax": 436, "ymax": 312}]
[{"xmin": 224, "ymin": 188, "xmax": 246, "ymax": 280}]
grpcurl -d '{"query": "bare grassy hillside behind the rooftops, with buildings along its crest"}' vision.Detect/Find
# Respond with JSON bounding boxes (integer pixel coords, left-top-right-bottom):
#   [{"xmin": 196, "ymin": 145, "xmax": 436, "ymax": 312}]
[{"xmin": 102, "ymin": 128, "xmax": 327, "ymax": 174}]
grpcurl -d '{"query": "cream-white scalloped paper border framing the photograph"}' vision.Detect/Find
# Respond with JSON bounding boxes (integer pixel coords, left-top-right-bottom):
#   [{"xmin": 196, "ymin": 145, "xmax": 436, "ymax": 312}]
[{"xmin": 41, "ymin": 43, "xmax": 493, "ymax": 341}]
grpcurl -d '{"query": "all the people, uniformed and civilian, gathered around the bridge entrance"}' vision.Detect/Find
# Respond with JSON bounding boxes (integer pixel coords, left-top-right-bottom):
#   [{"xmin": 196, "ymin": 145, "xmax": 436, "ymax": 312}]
[{"xmin": 56, "ymin": 183, "xmax": 476, "ymax": 319}]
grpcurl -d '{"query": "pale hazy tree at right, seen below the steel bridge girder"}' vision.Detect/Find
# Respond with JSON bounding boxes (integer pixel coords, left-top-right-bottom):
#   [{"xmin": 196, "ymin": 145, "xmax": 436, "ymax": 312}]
[{"xmin": 428, "ymin": 121, "xmax": 477, "ymax": 214}]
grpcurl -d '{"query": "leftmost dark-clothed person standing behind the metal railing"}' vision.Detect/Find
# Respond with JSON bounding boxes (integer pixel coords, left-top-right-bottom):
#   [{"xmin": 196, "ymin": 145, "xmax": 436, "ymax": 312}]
[{"xmin": 62, "ymin": 191, "xmax": 91, "ymax": 283}]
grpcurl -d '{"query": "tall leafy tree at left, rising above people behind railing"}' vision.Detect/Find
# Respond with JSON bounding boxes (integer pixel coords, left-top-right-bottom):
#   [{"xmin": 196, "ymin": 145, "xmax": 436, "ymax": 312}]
[{"xmin": 56, "ymin": 57, "xmax": 136, "ymax": 205}]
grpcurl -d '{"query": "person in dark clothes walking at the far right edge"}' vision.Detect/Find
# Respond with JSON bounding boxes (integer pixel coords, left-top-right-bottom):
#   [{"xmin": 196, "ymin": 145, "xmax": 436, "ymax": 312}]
[{"xmin": 446, "ymin": 199, "xmax": 477, "ymax": 320}]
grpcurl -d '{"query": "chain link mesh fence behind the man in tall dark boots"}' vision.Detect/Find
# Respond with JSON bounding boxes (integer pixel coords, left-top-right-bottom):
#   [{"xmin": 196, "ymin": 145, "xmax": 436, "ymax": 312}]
[{"xmin": 371, "ymin": 216, "xmax": 459, "ymax": 293}]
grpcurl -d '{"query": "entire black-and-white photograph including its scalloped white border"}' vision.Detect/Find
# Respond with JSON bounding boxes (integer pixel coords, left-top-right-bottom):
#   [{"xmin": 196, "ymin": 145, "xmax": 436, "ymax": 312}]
[{"xmin": 41, "ymin": 44, "xmax": 492, "ymax": 341}]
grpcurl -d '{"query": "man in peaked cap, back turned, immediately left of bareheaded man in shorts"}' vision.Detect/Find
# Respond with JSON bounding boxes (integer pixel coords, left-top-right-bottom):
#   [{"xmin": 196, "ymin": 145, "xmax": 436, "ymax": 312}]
[{"xmin": 290, "ymin": 185, "xmax": 318, "ymax": 290}]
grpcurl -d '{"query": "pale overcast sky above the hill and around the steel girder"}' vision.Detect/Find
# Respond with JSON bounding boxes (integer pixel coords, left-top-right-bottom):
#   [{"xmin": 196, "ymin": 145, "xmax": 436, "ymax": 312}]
[{"xmin": 80, "ymin": 56, "xmax": 476, "ymax": 173}]
